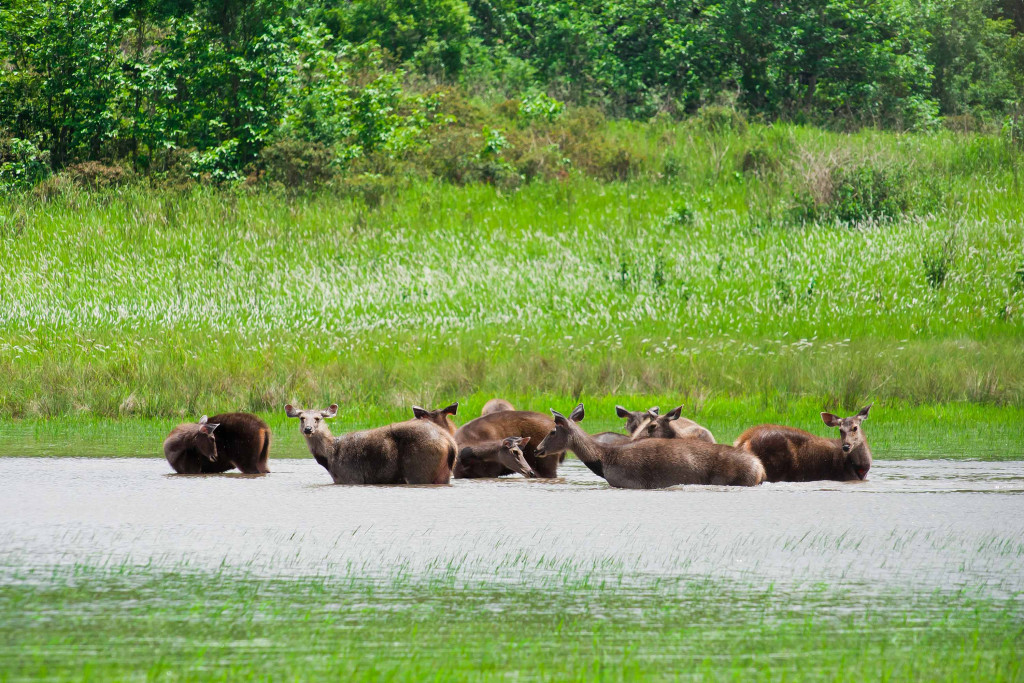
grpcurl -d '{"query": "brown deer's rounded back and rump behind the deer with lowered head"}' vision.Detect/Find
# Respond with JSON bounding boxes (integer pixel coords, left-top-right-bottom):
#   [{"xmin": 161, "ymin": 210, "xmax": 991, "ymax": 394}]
[{"xmin": 454, "ymin": 411, "xmax": 564, "ymax": 479}]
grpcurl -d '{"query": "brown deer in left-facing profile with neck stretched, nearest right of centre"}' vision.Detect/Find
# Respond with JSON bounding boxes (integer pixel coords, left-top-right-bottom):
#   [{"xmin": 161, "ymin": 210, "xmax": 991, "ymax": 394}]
[{"xmin": 538, "ymin": 403, "xmax": 765, "ymax": 488}]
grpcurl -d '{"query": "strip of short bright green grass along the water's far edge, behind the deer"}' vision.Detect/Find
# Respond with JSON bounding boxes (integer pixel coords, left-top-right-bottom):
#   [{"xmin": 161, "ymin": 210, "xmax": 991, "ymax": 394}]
[{"xmin": 0, "ymin": 394, "xmax": 1024, "ymax": 460}]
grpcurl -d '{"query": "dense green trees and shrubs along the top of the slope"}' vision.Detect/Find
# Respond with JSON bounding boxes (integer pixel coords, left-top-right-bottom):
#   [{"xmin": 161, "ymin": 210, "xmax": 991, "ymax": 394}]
[{"xmin": 0, "ymin": 0, "xmax": 1024, "ymax": 189}]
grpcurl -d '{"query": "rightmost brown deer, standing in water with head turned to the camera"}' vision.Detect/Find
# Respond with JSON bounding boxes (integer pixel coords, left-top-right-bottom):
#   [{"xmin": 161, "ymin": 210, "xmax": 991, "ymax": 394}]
[{"xmin": 736, "ymin": 405, "xmax": 871, "ymax": 481}]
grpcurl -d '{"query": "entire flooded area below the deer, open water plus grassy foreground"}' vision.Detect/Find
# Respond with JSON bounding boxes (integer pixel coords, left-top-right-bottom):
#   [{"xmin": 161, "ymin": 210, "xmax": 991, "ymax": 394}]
[{"xmin": 0, "ymin": 458, "xmax": 1024, "ymax": 681}]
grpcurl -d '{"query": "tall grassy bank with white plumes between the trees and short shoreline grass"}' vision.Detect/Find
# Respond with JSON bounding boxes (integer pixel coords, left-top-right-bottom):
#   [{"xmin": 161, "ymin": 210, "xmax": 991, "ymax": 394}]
[{"xmin": 0, "ymin": 122, "xmax": 1024, "ymax": 431}]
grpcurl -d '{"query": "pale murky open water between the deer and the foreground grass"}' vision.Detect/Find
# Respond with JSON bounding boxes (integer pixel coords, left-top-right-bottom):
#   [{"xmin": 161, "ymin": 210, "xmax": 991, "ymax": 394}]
[{"xmin": 0, "ymin": 458, "xmax": 1024, "ymax": 593}]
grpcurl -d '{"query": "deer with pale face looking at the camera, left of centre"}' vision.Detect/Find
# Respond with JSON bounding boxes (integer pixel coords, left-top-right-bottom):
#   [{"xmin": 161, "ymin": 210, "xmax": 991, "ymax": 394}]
[{"xmin": 285, "ymin": 404, "xmax": 457, "ymax": 484}]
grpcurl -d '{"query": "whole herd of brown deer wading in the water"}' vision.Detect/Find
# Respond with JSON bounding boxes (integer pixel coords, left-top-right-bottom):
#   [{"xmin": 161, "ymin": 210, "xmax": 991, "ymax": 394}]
[{"xmin": 164, "ymin": 398, "xmax": 871, "ymax": 488}]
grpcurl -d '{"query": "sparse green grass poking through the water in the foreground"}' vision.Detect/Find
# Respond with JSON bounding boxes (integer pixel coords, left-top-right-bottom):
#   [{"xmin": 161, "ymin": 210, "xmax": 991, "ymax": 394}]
[{"xmin": 0, "ymin": 566, "xmax": 1024, "ymax": 681}]
